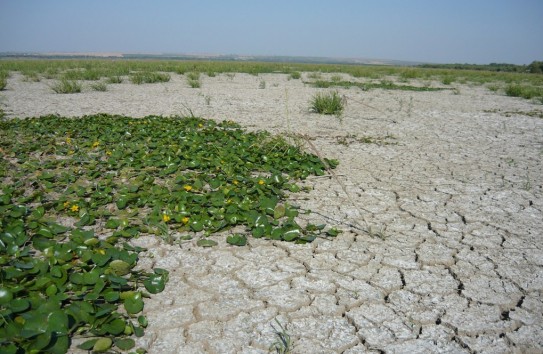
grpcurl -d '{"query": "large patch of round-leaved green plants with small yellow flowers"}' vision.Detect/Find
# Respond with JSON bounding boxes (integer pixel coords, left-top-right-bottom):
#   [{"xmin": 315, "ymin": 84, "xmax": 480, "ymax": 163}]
[{"xmin": 0, "ymin": 115, "xmax": 337, "ymax": 353}]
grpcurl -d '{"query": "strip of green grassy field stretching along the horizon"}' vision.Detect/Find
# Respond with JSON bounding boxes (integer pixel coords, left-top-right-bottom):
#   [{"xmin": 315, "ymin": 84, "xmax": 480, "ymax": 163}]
[{"xmin": 0, "ymin": 59, "xmax": 543, "ymax": 103}]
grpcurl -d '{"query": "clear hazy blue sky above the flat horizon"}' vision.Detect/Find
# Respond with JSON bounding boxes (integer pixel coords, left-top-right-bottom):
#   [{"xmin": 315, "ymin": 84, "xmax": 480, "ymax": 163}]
[{"xmin": 0, "ymin": 0, "xmax": 543, "ymax": 64}]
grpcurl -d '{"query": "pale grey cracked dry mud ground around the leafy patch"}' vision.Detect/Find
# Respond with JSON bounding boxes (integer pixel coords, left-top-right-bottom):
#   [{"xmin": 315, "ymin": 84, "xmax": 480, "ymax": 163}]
[{"xmin": 2, "ymin": 74, "xmax": 543, "ymax": 354}]
